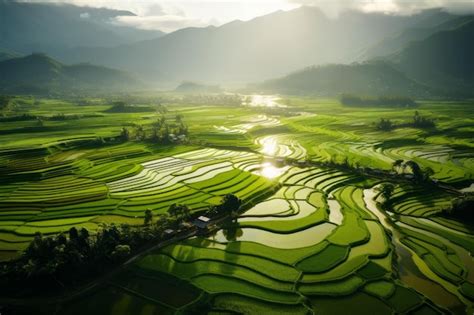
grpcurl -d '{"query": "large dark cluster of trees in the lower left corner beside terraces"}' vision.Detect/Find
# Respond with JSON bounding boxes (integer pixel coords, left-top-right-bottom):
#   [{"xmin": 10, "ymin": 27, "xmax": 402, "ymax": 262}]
[{"xmin": 0, "ymin": 220, "xmax": 171, "ymax": 295}]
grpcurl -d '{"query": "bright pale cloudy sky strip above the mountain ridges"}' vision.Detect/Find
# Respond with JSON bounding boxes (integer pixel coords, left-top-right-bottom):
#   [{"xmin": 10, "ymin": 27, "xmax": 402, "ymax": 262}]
[{"xmin": 21, "ymin": 0, "xmax": 474, "ymax": 32}]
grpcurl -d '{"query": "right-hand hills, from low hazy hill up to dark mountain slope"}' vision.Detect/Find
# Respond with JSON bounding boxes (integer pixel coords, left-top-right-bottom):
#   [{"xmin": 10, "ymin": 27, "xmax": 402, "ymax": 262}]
[{"xmin": 260, "ymin": 17, "xmax": 474, "ymax": 97}]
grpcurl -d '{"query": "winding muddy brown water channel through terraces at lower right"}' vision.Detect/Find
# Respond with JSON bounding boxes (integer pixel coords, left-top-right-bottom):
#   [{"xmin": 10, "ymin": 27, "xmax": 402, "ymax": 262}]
[{"xmin": 364, "ymin": 189, "xmax": 466, "ymax": 314}]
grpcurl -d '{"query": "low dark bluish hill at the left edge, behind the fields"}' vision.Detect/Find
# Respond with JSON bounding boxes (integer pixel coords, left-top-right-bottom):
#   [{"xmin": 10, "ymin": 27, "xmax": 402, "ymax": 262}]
[{"xmin": 0, "ymin": 54, "xmax": 138, "ymax": 94}]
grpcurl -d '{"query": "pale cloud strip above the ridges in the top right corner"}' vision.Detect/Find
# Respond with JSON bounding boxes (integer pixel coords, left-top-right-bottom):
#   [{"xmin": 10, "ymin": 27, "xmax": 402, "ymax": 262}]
[{"xmin": 289, "ymin": 0, "xmax": 474, "ymax": 16}]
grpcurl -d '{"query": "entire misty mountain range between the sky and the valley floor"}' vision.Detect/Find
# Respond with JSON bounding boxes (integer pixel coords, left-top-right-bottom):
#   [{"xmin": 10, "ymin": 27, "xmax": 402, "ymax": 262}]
[{"xmin": 0, "ymin": 0, "xmax": 474, "ymax": 97}]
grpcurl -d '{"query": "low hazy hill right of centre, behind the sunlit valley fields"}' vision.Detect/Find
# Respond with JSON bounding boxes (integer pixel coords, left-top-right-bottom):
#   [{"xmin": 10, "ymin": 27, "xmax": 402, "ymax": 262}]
[{"xmin": 251, "ymin": 61, "xmax": 430, "ymax": 97}]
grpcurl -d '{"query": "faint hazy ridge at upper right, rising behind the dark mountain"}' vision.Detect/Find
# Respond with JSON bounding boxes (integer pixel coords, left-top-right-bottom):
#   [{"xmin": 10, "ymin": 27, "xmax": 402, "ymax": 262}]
[{"xmin": 359, "ymin": 12, "xmax": 474, "ymax": 60}]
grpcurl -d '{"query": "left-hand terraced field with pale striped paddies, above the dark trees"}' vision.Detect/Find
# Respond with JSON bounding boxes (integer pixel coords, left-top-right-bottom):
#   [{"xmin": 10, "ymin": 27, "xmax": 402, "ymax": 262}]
[{"xmin": 0, "ymin": 146, "xmax": 279, "ymax": 256}]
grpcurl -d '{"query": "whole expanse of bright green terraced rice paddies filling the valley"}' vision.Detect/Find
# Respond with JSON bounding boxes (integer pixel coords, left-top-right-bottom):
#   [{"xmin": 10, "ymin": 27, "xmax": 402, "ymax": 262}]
[{"xmin": 0, "ymin": 97, "xmax": 474, "ymax": 314}]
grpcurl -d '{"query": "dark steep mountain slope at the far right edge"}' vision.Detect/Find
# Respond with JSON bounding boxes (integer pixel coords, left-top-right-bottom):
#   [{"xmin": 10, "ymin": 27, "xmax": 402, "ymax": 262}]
[{"xmin": 391, "ymin": 18, "xmax": 474, "ymax": 95}]
